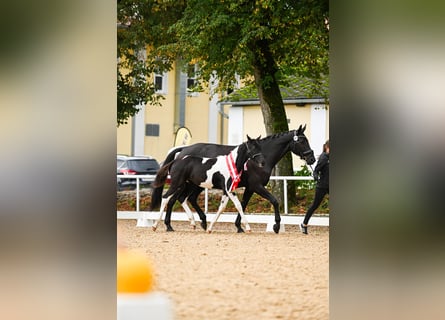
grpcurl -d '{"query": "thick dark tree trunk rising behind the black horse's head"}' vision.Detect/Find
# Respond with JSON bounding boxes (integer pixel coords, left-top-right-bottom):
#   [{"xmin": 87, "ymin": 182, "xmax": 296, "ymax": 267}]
[{"xmin": 254, "ymin": 40, "xmax": 296, "ymax": 209}]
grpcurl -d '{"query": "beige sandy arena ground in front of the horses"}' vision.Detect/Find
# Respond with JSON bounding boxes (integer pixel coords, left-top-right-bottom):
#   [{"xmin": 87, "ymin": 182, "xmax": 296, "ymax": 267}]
[{"xmin": 117, "ymin": 220, "xmax": 329, "ymax": 320}]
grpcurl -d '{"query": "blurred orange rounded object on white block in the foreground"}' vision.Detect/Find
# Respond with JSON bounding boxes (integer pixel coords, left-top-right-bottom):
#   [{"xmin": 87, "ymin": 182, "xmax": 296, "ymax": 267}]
[{"xmin": 117, "ymin": 249, "xmax": 154, "ymax": 293}]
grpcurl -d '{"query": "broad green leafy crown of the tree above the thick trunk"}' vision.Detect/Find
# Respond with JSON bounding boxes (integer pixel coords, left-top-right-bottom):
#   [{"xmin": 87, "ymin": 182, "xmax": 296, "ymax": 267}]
[{"xmin": 169, "ymin": 0, "xmax": 329, "ymax": 88}]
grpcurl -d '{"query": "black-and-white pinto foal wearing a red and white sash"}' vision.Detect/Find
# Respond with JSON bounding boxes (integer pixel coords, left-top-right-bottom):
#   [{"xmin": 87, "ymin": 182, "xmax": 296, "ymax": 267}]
[{"xmin": 152, "ymin": 136, "xmax": 264, "ymax": 232}]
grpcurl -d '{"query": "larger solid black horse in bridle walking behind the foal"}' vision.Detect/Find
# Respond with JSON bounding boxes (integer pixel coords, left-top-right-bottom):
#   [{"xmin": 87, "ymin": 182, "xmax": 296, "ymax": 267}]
[{"xmin": 150, "ymin": 125, "xmax": 315, "ymax": 233}]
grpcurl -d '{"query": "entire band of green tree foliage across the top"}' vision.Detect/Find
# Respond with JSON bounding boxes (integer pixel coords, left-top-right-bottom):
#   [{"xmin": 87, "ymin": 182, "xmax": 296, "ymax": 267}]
[{"xmin": 117, "ymin": 0, "xmax": 329, "ymax": 124}]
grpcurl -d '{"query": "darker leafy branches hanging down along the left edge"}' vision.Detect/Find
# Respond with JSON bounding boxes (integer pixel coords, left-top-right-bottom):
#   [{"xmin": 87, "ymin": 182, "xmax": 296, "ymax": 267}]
[{"xmin": 117, "ymin": 0, "xmax": 184, "ymax": 126}]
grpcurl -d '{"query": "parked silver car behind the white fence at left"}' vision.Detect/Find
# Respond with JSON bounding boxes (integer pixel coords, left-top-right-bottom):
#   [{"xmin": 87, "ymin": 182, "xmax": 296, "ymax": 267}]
[{"xmin": 116, "ymin": 155, "xmax": 159, "ymax": 190}]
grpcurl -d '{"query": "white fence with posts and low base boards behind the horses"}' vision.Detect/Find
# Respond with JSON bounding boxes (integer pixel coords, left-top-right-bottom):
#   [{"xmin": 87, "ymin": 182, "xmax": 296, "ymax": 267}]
[{"xmin": 117, "ymin": 175, "xmax": 329, "ymax": 229}]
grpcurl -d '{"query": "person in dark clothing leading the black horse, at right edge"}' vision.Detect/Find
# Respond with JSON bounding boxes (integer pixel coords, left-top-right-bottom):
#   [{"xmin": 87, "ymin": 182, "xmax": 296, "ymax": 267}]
[{"xmin": 300, "ymin": 140, "xmax": 329, "ymax": 234}]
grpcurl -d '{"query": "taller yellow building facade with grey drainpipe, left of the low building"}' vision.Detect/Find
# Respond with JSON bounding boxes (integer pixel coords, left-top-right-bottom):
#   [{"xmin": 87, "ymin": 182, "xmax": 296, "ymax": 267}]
[{"xmin": 117, "ymin": 60, "xmax": 228, "ymax": 161}]
